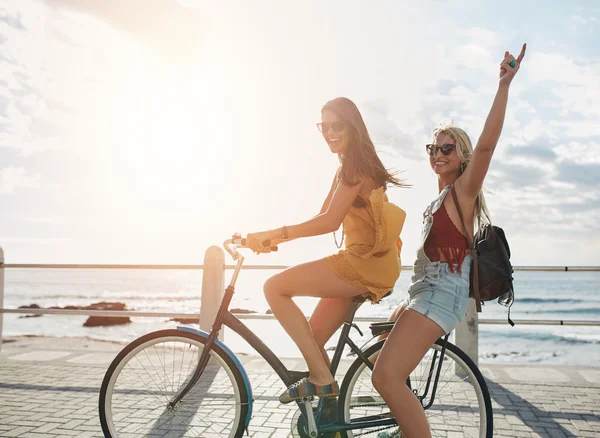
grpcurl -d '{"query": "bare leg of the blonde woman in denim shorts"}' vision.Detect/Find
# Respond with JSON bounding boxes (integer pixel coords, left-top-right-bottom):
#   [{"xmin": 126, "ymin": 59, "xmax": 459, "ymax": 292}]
[{"xmin": 372, "ymin": 309, "xmax": 444, "ymax": 438}]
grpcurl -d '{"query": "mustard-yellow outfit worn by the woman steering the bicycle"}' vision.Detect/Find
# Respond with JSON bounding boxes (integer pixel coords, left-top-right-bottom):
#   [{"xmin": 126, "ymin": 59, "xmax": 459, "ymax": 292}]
[{"xmin": 325, "ymin": 187, "xmax": 406, "ymax": 303}]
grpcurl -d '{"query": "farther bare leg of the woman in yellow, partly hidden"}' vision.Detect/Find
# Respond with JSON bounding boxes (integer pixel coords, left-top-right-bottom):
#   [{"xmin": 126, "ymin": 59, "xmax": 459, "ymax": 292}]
[{"xmin": 308, "ymin": 298, "xmax": 353, "ymax": 367}]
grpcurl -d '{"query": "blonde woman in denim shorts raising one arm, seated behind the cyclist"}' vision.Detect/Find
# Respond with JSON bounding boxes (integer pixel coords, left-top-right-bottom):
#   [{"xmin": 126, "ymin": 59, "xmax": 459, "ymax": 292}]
[{"xmin": 372, "ymin": 45, "xmax": 526, "ymax": 438}]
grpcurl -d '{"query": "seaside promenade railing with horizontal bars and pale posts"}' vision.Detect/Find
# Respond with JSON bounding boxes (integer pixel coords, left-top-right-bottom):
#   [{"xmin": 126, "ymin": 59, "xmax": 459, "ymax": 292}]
[{"xmin": 0, "ymin": 246, "xmax": 600, "ymax": 361}]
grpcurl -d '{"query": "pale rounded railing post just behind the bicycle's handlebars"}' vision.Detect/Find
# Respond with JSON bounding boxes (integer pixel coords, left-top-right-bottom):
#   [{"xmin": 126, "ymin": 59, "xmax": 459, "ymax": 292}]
[{"xmin": 200, "ymin": 245, "xmax": 225, "ymax": 341}]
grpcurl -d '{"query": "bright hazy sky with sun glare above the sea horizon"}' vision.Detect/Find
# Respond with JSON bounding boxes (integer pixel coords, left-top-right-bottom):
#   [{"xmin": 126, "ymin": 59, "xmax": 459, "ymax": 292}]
[{"xmin": 0, "ymin": 0, "xmax": 600, "ymax": 266}]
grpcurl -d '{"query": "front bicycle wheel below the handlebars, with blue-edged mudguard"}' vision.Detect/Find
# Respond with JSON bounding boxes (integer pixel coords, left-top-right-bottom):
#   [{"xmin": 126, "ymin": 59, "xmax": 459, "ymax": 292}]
[{"xmin": 99, "ymin": 330, "xmax": 248, "ymax": 438}]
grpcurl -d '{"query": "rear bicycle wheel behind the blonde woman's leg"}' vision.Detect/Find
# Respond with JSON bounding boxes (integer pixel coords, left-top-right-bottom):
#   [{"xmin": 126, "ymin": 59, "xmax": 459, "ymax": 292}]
[{"xmin": 338, "ymin": 340, "xmax": 494, "ymax": 438}]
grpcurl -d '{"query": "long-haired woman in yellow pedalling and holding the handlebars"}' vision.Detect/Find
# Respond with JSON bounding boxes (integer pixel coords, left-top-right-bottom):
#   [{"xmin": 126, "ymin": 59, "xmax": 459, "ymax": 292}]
[{"xmin": 248, "ymin": 97, "xmax": 406, "ymax": 403}]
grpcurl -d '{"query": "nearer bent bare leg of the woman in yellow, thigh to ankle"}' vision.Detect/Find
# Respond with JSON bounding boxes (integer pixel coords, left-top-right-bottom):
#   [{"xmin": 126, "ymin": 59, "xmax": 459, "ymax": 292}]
[{"xmin": 264, "ymin": 260, "xmax": 368, "ymax": 385}]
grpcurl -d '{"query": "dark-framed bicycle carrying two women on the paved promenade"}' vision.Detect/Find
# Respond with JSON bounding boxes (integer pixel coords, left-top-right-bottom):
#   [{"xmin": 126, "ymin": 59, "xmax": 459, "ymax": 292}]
[{"xmin": 99, "ymin": 235, "xmax": 493, "ymax": 438}]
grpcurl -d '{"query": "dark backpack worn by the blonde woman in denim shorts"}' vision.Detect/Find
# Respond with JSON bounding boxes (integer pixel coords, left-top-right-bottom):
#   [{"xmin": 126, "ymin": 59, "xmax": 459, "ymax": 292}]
[{"xmin": 451, "ymin": 186, "xmax": 514, "ymax": 326}]
